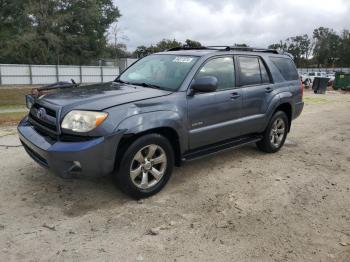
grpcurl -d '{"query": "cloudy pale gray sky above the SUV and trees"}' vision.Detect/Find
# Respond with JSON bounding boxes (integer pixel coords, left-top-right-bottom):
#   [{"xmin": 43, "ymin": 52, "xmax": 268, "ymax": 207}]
[{"xmin": 114, "ymin": 0, "xmax": 350, "ymax": 51}]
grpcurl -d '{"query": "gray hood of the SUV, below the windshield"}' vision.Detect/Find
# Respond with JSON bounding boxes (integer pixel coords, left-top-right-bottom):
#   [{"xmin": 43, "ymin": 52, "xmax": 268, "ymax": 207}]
[{"xmin": 39, "ymin": 82, "xmax": 171, "ymax": 110}]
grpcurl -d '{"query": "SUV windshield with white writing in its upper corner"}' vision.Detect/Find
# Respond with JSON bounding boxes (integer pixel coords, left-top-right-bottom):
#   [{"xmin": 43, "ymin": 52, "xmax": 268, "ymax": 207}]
[{"xmin": 118, "ymin": 55, "xmax": 198, "ymax": 91}]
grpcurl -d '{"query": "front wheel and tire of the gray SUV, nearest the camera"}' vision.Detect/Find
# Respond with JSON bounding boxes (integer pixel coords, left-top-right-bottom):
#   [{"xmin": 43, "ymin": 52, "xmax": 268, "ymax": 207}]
[{"xmin": 115, "ymin": 134, "xmax": 174, "ymax": 199}]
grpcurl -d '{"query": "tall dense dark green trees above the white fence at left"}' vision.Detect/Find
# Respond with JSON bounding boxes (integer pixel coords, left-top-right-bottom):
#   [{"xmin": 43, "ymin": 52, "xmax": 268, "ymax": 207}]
[{"xmin": 0, "ymin": 0, "xmax": 120, "ymax": 64}]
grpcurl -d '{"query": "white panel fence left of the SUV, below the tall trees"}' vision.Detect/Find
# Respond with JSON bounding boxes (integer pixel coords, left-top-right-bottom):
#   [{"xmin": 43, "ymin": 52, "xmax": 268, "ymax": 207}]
[{"xmin": 0, "ymin": 64, "xmax": 119, "ymax": 85}]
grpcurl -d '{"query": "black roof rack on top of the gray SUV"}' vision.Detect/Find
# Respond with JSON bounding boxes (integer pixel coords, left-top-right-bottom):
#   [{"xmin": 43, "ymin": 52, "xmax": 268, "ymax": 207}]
[{"xmin": 167, "ymin": 45, "xmax": 284, "ymax": 54}]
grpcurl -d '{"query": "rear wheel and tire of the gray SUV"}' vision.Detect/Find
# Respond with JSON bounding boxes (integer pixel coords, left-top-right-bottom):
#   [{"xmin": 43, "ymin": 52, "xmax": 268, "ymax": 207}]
[{"xmin": 256, "ymin": 111, "xmax": 289, "ymax": 153}]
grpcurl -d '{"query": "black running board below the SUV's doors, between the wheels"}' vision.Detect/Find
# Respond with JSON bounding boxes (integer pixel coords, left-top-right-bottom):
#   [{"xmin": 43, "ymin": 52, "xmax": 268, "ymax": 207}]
[{"xmin": 182, "ymin": 136, "xmax": 263, "ymax": 161}]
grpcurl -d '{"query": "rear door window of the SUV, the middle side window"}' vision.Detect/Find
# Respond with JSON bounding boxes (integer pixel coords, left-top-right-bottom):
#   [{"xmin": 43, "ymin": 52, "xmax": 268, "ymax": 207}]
[{"xmin": 239, "ymin": 56, "xmax": 261, "ymax": 85}]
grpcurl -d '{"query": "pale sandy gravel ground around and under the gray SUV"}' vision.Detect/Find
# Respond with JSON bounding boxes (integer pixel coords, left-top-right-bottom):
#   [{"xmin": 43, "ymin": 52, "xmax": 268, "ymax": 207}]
[{"xmin": 0, "ymin": 92, "xmax": 350, "ymax": 262}]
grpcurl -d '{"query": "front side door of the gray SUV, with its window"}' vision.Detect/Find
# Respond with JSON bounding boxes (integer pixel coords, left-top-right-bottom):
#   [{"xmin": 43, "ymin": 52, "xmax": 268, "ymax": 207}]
[{"xmin": 187, "ymin": 56, "xmax": 242, "ymax": 149}]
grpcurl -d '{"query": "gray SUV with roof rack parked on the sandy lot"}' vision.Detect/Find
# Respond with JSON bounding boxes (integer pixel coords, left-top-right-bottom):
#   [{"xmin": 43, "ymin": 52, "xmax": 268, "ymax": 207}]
[{"xmin": 18, "ymin": 46, "xmax": 304, "ymax": 198}]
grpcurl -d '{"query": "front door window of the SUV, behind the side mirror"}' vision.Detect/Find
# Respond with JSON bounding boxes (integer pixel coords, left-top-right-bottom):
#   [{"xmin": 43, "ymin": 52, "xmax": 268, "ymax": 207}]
[{"xmin": 195, "ymin": 57, "xmax": 235, "ymax": 90}]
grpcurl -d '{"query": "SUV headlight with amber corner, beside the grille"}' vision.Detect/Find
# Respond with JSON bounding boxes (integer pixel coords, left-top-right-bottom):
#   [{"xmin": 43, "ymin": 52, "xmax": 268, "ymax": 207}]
[{"xmin": 61, "ymin": 110, "xmax": 108, "ymax": 132}]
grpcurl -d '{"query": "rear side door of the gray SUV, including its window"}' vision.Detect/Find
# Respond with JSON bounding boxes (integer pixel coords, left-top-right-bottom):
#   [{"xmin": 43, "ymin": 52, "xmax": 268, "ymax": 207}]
[{"xmin": 236, "ymin": 55, "xmax": 274, "ymax": 135}]
